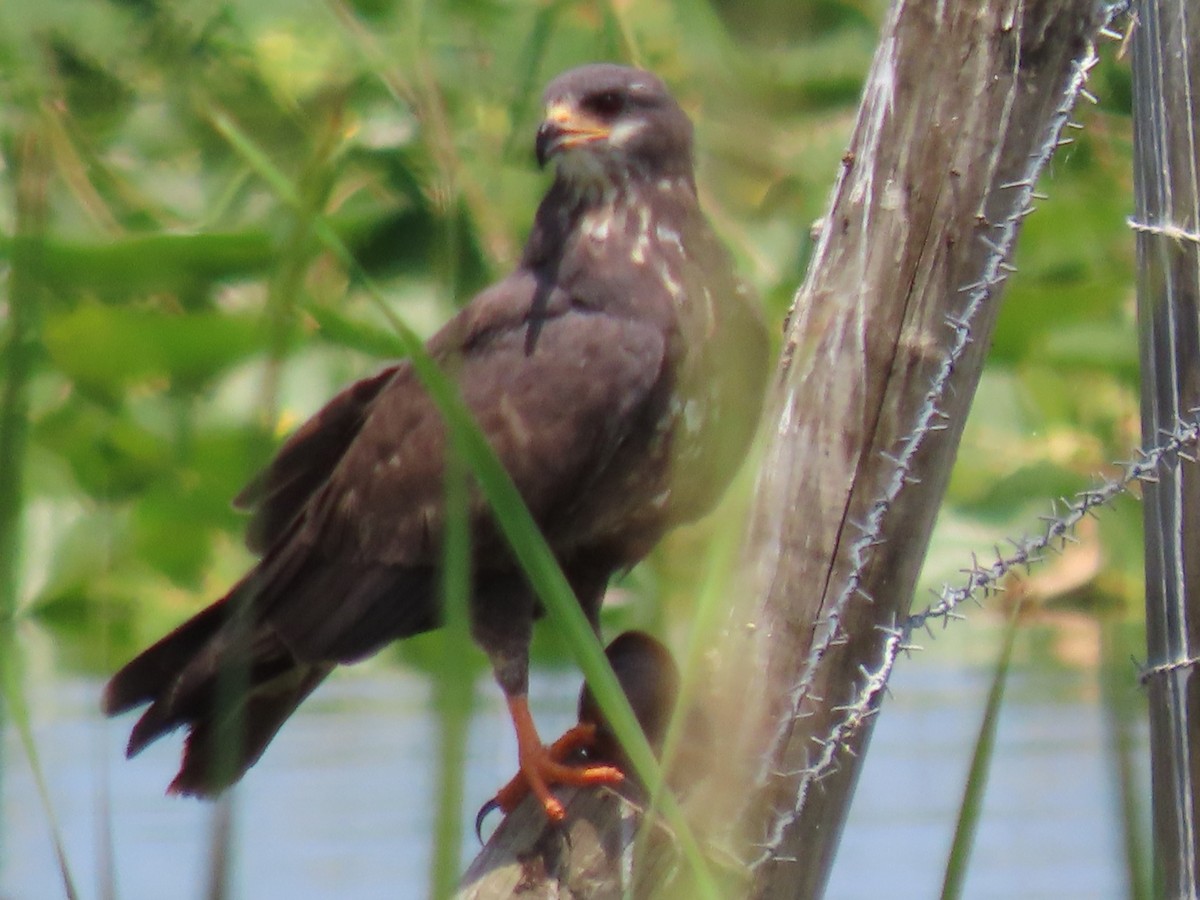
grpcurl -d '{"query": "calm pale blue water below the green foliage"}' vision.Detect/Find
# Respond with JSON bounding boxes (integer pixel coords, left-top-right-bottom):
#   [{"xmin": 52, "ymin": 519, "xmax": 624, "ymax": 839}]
[{"xmin": 0, "ymin": 626, "xmax": 1148, "ymax": 900}]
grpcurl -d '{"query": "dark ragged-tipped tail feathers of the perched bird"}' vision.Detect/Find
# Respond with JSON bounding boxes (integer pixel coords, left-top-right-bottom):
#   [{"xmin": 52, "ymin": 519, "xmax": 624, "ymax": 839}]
[{"xmin": 102, "ymin": 528, "xmax": 427, "ymax": 796}]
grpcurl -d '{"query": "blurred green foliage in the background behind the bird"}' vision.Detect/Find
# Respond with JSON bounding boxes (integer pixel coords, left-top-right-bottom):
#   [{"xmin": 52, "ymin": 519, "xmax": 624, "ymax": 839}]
[{"xmin": 0, "ymin": 0, "xmax": 1140, "ymax": 668}]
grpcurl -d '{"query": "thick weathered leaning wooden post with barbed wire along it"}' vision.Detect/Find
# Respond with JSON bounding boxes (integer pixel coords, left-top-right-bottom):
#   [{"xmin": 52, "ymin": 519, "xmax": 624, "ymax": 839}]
[{"xmin": 461, "ymin": 0, "xmax": 1112, "ymax": 900}]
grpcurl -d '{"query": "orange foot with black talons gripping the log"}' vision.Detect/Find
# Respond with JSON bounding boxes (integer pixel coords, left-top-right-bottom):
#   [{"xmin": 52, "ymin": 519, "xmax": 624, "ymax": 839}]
[{"xmin": 475, "ymin": 697, "xmax": 625, "ymax": 834}]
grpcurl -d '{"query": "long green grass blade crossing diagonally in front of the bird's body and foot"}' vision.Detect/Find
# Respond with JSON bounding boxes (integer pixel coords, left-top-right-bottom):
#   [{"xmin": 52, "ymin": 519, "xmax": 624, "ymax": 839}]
[{"xmin": 212, "ymin": 103, "xmax": 720, "ymax": 900}]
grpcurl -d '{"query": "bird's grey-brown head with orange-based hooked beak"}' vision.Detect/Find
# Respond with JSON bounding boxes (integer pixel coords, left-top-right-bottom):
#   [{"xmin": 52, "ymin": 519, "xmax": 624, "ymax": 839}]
[{"xmin": 536, "ymin": 64, "xmax": 692, "ymax": 190}]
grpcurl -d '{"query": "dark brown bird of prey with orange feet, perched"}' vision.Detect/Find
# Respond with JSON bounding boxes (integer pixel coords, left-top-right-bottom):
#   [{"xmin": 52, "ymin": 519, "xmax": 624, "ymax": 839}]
[{"xmin": 110, "ymin": 64, "xmax": 768, "ymax": 818}]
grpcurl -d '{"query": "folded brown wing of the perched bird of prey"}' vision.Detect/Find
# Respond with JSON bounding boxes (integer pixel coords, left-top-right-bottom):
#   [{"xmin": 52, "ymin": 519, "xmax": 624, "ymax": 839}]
[{"xmin": 242, "ymin": 274, "xmax": 666, "ymax": 661}]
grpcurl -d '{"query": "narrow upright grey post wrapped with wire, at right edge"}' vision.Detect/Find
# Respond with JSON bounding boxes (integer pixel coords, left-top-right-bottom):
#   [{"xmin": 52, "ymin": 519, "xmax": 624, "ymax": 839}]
[{"xmin": 1130, "ymin": 0, "xmax": 1200, "ymax": 896}]
